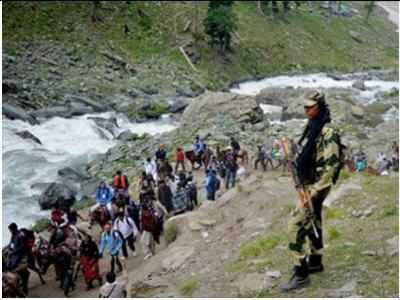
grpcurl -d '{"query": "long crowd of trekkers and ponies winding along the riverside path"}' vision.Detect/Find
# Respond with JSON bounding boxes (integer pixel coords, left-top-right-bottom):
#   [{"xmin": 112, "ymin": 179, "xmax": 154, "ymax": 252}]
[{"xmin": 3, "ymin": 129, "xmax": 398, "ymax": 297}]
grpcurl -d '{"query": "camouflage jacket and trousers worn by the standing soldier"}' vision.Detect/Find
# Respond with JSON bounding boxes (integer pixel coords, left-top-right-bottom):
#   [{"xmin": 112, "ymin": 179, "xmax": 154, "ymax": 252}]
[{"xmin": 289, "ymin": 125, "xmax": 339, "ymax": 259}]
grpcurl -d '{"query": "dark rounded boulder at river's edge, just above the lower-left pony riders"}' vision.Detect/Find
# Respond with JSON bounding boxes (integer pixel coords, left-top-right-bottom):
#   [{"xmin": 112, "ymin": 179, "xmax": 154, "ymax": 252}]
[{"xmin": 38, "ymin": 182, "xmax": 77, "ymax": 209}]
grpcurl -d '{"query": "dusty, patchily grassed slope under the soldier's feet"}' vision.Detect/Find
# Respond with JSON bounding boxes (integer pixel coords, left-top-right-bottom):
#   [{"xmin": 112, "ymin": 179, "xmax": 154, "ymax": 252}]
[{"xmin": 26, "ymin": 164, "xmax": 398, "ymax": 297}]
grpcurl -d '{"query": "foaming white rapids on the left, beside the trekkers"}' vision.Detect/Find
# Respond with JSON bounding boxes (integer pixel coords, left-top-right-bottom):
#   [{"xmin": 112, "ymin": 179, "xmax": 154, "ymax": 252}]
[{"xmin": 2, "ymin": 113, "xmax": 175, "ymax": 243}]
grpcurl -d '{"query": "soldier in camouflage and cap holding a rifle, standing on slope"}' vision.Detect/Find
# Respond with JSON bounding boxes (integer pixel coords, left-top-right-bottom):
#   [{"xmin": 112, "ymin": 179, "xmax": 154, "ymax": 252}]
[{"xmin": 281, "ymin": 91, "xmax": 344, "ymax": 292}]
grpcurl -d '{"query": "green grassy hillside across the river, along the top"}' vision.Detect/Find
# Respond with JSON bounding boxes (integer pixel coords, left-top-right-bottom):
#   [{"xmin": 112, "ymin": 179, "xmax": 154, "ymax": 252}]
[{"xmin": 3, "ymin": 1, "xmax": 398, "ymax": 92}]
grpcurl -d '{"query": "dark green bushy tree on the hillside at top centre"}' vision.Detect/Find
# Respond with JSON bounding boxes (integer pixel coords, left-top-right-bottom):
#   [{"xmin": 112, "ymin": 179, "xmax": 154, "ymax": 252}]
[{"xmin": 204, "ymin": 1, "xmax": 237, "ymax": 53}]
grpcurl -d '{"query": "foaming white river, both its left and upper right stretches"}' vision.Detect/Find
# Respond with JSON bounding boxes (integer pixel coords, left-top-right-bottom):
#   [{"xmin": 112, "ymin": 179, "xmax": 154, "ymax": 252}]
[{"xmin": 2, "ymin": 73, "xmax": 399, "ymax": 243}]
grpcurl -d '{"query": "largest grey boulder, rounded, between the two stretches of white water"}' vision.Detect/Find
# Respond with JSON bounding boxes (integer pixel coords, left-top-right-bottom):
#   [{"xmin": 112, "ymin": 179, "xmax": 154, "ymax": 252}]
[{"xmin": 181, "ymin": 92, "xmax": 264, "ymax": 128}]
